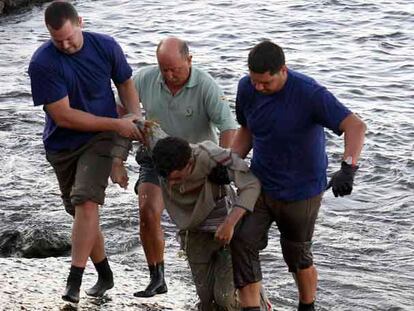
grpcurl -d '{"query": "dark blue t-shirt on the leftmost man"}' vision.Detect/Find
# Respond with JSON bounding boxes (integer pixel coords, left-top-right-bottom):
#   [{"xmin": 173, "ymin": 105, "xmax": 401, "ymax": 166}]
[{"xmin": 29, "ymin": 32, "xmax": 132, "ymax": 151}]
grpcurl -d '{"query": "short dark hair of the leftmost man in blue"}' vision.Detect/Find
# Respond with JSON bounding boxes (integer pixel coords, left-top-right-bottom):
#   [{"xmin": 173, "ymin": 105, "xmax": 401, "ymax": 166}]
[{"xmin": 45, "ymin": 1, "xmax": 79, "ymax": 30}]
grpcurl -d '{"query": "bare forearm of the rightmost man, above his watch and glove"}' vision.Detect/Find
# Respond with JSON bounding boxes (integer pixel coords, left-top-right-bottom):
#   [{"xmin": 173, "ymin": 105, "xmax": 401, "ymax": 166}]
[{"xmin": 339, "ymin": 114, "xmax": 367, "ymax": 166}]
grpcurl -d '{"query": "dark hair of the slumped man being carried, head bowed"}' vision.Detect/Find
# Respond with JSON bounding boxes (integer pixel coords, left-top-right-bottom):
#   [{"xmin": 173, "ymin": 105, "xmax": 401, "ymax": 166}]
[{"xmin": 152, "ymin": 137, "xmax": 192, "ymax": 178}]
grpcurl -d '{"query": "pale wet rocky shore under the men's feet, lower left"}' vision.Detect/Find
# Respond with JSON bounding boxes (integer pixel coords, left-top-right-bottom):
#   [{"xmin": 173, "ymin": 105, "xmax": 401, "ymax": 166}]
[{"xmin": 0, "ymin": 255, "xmax": 197, "ymax": 311}]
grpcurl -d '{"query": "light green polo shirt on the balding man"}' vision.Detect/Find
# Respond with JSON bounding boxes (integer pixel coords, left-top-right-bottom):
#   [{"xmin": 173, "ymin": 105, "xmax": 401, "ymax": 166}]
[{"xmin": 134, "ymin": 66, "xmax": 238, "ymax": 143}]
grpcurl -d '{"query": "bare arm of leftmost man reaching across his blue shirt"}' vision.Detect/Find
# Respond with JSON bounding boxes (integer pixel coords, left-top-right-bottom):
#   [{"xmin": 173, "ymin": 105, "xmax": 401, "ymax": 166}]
[{"xmin": 45, "ymin": 96, "xmax": 141, "ymax": 139}]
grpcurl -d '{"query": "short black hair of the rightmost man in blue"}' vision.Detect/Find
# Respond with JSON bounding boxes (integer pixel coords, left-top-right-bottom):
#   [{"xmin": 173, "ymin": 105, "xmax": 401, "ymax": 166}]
[{"xmin": 247, "ymin": 40, "xmax": 285, "ymax": 75}]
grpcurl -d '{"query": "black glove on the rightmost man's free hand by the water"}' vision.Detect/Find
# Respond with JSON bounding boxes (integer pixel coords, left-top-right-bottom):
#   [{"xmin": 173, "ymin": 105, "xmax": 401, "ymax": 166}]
[{"xmin": 326, "ymin": 161, "xmax": 358, "ymax": 197}]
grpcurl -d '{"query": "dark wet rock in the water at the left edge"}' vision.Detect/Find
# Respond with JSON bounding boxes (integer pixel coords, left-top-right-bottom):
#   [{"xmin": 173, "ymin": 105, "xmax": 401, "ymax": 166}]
[{"xmin": 0, "ymin": 228, "xmax": 71, "ymax": 258}]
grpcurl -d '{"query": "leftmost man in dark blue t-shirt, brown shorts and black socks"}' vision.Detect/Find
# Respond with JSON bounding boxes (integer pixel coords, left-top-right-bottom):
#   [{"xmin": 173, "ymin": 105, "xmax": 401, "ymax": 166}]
[{"xmin": 29, "ymin": 1, "xmax": 142, "ymax": 303}]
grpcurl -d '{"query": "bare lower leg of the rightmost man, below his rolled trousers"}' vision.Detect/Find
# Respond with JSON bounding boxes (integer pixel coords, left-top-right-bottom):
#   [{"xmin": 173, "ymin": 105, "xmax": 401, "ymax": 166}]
[{"xmin": 296, "ymin": 266, "xmax": 318, "ymax": 303}]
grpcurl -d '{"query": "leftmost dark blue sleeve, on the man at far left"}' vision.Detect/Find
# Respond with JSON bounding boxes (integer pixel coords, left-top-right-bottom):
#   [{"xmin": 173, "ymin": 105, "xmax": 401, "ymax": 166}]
[{"xmin": 29, "ymin": 62, "xmax": 68, "ymax": 106}]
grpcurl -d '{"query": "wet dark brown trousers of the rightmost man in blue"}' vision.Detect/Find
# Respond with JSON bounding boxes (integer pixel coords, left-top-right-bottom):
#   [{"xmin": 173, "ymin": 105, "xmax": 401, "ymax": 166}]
[{"xmin": 231, "ymin": 193, "xmax": 322, "ymax": 288}]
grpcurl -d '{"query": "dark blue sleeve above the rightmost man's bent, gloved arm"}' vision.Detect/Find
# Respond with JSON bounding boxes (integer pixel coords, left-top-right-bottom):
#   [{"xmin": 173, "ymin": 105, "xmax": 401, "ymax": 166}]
[{"xmin": 312, "ymin": 87, "xmax": 352, "ymax": 135}]
